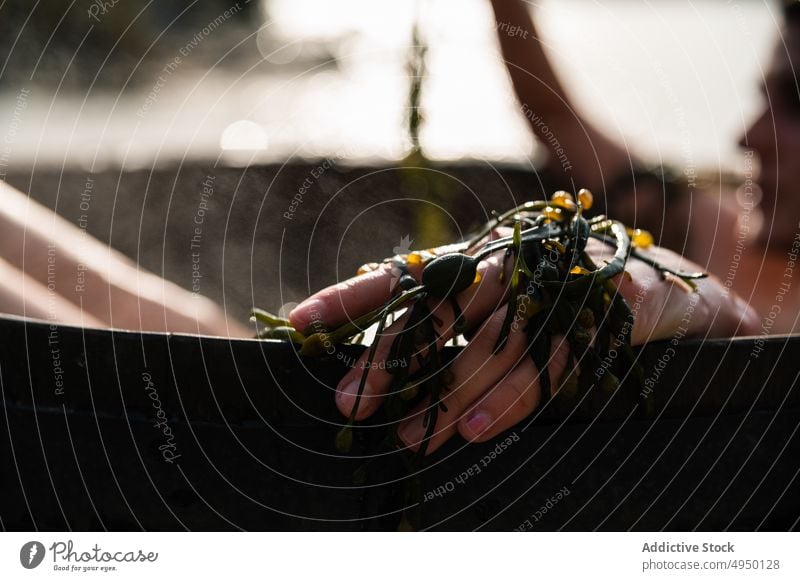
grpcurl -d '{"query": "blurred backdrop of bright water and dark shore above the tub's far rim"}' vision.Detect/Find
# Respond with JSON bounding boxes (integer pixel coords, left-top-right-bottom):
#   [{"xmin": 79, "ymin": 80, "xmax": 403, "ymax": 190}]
[{"xmin": 0, "ymin": 0, "xmax": 779, "ymax": 168}]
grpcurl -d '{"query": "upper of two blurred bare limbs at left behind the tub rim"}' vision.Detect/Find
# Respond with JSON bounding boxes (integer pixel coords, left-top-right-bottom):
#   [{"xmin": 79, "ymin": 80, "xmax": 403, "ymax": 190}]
[{"xmin": 0, "ymin": 184, "xmax": 247, "ymax": 336}]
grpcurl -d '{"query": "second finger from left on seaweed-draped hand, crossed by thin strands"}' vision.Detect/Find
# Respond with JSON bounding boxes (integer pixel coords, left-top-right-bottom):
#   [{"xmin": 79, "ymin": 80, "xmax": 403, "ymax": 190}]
[{"xmin": 336, "ymin": 255, "xmax": 507, "ymax": 419}]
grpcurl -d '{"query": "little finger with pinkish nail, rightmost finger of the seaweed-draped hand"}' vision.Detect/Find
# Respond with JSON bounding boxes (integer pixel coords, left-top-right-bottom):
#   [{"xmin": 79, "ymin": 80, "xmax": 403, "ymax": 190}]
[{"xmin": 458, "ymin": 336, "xmax": 569, "ymax": 442}]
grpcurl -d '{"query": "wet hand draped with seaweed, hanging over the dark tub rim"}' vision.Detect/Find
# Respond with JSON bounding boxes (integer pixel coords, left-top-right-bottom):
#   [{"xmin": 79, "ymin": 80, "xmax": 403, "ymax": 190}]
[{"xmin": 289, "ymin": 239, "xmax": 758, "ymax": 453}]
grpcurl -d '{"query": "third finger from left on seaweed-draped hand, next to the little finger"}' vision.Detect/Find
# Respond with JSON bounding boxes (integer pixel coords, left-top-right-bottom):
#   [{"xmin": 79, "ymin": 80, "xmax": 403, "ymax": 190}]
[{"xmin": 398, "ymin": 307, "xmax": 528, "ymax": 454}]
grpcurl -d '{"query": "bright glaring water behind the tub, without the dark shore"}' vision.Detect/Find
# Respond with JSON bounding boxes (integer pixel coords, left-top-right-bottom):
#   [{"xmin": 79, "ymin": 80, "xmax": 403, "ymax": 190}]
[{"xmin": 0, "ymin": 0, "xmax": 779, "ymax": 168}]
